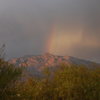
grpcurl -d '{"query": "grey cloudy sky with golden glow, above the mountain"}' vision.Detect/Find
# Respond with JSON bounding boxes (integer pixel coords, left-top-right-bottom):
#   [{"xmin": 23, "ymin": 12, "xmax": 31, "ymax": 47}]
[{"xmin": 0, "ymin": 0, "xmax": 100, "ymax": 62}]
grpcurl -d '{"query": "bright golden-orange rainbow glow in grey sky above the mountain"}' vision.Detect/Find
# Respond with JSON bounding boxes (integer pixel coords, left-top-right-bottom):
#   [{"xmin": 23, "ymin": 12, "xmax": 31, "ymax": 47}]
[{"xmin": 45, "ymin": 24, "xmax": 83, "ymax": 54}]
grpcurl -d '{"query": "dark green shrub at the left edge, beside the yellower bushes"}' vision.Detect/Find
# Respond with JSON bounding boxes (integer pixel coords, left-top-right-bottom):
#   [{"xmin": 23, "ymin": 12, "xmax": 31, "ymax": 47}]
[{"xmin": 0, "ymin": 59, "xmax": 22, "ymax": 100}]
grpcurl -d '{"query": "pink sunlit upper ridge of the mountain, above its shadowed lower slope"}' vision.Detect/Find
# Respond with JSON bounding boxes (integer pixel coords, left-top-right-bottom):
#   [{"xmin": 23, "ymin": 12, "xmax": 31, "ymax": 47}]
[{"xmin": 9, "ymin": 53, "xmax": 97, "ymax": 67}]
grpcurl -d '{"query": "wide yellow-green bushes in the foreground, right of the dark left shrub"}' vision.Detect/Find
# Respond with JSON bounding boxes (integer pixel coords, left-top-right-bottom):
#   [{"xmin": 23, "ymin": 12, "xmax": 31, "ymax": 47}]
[{"xmin": 13, "ymin": 65, "xmax": 100, "ymax": 100}]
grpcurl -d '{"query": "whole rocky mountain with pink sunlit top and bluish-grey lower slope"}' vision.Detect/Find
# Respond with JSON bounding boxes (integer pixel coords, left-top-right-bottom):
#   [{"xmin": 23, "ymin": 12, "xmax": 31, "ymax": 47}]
[{"xmin": 9, "ymin": 53, "xmax": 98, "ymax": 75}]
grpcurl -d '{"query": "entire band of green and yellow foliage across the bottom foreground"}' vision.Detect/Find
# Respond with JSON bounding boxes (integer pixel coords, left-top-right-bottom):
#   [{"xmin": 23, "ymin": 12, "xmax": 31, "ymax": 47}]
[{"xmin": 0, "ymin": 60, "xmax": 100, "ymax": 100}]
